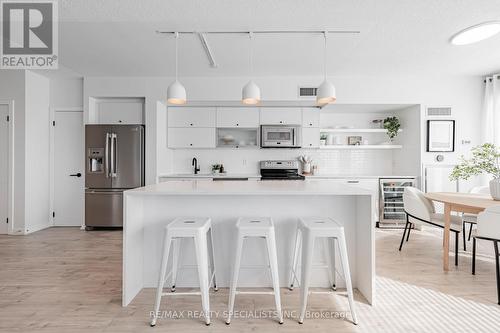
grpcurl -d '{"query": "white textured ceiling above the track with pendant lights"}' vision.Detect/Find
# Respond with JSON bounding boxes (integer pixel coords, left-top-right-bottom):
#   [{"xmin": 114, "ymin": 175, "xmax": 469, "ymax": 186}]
[{"xmin": 59, "ymin": 0, "xmax": 500, "ymax": 76}]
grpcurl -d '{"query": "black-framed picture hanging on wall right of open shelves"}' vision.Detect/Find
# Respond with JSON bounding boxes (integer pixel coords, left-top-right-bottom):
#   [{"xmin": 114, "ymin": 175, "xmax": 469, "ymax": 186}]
[{"xmin": 427, "ymin": 120, "xmax": 455, "ymax": 152}]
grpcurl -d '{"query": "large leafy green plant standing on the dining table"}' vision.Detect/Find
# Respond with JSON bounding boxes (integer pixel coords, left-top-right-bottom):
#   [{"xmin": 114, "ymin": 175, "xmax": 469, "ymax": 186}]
[{"xmin": 450, "ymin": 143, "xmax": 500, "ymax": 200}]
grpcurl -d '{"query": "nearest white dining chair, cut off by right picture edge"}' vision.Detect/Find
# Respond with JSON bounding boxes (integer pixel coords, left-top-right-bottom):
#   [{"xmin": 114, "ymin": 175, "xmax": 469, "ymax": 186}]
[{"xmin": 472, "ymin": 204, "xmax": 500, "ymax": 305}]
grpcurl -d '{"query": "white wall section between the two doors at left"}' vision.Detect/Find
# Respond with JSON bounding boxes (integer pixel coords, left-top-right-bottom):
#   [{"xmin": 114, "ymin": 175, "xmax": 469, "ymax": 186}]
[{"xmin": 0, "ymin": 70, "xmax": 53, "ymax": 234}]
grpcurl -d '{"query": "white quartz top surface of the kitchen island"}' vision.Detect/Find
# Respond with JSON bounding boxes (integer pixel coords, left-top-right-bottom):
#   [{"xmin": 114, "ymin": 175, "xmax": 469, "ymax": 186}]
[{"xmin": 124, "ymin": 179, "xmax": 376, "ymax": 195}]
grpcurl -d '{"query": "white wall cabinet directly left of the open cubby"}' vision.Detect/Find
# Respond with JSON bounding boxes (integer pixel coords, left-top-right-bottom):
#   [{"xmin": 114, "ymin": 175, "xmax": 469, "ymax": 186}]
[{"xmin": 167, "ymin": 127, "xmax": 215, "ymax": 149}]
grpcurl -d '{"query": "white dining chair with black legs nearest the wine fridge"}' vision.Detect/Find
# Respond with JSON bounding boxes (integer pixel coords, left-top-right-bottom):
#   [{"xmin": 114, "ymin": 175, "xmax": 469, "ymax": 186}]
[{"xmin": 399, "ymin": 187, "xmax": 463, "ymax": 266}]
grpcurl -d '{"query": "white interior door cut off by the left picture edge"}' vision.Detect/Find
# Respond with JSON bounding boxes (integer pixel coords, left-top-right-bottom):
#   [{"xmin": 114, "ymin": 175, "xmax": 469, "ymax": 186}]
[{"xmin": 0, "ymin": 104, "xmax": 9, "ymax": 234}]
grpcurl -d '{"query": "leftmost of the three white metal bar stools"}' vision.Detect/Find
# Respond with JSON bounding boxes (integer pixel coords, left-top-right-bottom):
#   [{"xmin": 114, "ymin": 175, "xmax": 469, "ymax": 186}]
[{"xmin": 151, "ymin": 217, "xmax": 217, "ymax": 326}]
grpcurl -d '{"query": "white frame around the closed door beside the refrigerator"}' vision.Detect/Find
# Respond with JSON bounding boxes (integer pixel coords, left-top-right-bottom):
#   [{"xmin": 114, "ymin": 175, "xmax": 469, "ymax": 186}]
[{"xmin": 49, "ymin": 106, "xmax": 85, "ymax": 230}]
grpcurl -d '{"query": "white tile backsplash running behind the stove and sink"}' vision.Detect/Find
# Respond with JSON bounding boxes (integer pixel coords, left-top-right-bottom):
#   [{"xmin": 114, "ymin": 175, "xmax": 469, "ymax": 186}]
[{"xmin": 171, "ymin": 149, "xmax": 392, "ymax": 176}]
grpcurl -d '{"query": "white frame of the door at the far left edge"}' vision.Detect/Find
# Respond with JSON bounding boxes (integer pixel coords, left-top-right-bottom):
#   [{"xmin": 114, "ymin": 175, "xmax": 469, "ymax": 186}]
[{"xmin": 0, "ymin": 99, "xmax": 15, "ymax": 235}]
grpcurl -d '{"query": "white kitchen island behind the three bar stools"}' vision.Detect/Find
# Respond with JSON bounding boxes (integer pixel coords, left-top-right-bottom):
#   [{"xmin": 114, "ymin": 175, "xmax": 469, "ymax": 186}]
[{"xmin": 122, "ymin": 180, "xmax": 376, "ymax": 306}]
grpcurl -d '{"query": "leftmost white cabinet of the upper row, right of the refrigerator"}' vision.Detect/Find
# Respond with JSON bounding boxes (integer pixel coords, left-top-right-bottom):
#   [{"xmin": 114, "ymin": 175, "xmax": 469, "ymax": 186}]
[{"xmin": 168, "ymin": 107, "xmax": 215, "ymax": 127}]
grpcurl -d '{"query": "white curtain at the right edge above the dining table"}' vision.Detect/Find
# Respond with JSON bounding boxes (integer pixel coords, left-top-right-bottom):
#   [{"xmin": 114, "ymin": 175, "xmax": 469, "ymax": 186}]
[{"xmin": 481, "ymin": 74, "xmax": 500, "ymax": 146}]
